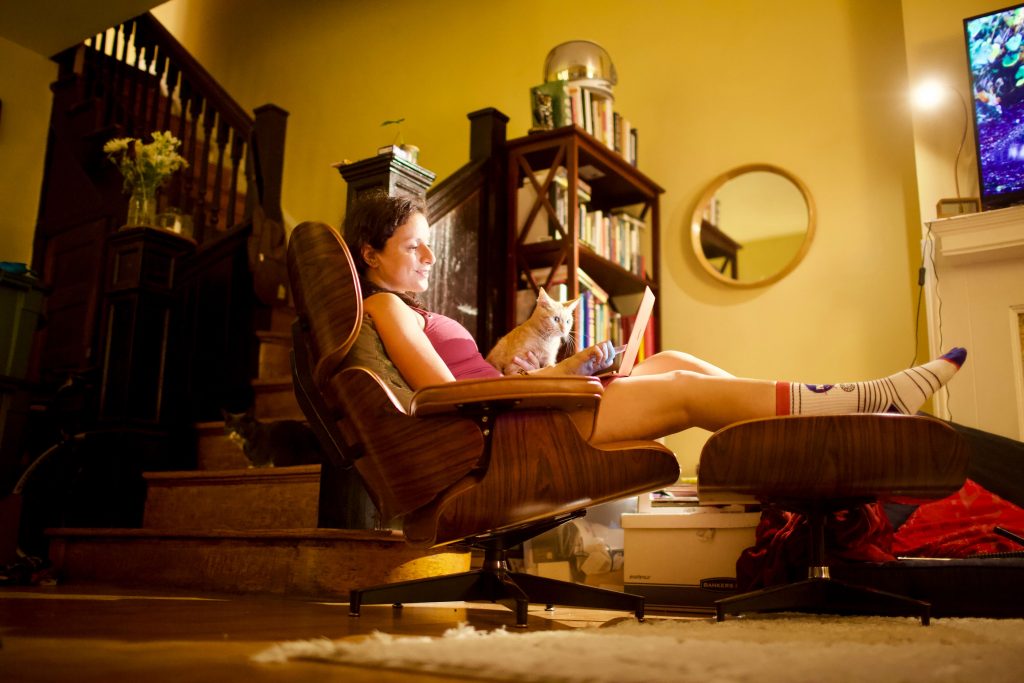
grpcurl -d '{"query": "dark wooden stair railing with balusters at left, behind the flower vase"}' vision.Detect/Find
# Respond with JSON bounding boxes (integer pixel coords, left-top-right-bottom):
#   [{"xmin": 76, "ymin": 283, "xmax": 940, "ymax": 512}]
[{"xmin": 34, "ymin": 13, "xmax": 288, "ymax": 444}]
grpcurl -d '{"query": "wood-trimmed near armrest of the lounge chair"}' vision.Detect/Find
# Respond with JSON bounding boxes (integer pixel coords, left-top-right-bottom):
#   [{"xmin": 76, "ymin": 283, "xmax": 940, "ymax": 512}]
[{"xmin": 410, "ymin": 376, "xmax": 604, "ymax": 439}]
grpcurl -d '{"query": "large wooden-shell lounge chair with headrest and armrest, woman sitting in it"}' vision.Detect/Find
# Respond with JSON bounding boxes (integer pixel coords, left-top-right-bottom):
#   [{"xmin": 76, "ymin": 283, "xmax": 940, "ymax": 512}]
[{"xmin": 288, "ymin": 222, "xmax": 679, "ymax": 627}]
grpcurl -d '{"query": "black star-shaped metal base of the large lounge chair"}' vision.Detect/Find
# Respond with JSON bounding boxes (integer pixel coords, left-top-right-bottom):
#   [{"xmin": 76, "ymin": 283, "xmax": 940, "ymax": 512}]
[{"xmin": 348, "ymin": 549, "xmax": 644, "ymax": 628}]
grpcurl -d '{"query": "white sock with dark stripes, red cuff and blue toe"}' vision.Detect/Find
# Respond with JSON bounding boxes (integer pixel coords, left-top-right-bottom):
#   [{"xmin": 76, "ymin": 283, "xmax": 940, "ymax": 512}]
[{"xmin": 775, "ymin": 347, "xmax": 967, "ymax": 415}]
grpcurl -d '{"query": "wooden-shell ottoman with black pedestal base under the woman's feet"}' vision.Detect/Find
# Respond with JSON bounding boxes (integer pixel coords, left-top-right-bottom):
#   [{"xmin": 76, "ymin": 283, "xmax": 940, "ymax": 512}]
[{"xmin": 697, "ymin": 415, "xmax": 970, "ymax": 626}]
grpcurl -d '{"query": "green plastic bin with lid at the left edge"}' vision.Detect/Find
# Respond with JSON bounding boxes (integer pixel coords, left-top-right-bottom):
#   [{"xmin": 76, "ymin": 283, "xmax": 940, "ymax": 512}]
[{"xmin": 0, "ymin": 270, "xmax": 45, "ymax": 380}]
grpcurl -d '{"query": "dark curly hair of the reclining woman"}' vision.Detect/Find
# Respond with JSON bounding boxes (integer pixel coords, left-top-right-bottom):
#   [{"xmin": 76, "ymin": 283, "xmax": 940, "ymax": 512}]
[{"xmin": 342, "ymin": 189, "xmax": 426, "ymax": 306}]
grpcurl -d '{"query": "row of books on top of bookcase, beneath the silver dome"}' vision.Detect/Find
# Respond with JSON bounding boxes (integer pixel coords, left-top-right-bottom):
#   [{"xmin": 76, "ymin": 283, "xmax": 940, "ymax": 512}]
[{"xmin": 529, "ymin": 81, "xmax": 637, "ymax": 166}]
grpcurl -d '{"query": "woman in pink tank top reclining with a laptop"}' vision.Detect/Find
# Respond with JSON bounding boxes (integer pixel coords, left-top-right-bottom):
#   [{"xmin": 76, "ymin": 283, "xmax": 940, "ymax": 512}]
[{"xmin": 344, "ymin": 194, "xmax": 967, "ymax": 443}]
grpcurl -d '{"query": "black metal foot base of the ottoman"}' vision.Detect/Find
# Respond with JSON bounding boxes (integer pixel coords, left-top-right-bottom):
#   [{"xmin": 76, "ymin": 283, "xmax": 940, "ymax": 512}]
[{"xmin": 715, "ymin": 578, "xmax": 932, "ymax": 626}]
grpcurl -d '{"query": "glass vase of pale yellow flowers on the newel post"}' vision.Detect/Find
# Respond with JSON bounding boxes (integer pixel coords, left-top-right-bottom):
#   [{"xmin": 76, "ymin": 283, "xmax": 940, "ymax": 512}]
[{"xmin": 103, "ymin": 131, "xmax": 188, "ymax": 227}]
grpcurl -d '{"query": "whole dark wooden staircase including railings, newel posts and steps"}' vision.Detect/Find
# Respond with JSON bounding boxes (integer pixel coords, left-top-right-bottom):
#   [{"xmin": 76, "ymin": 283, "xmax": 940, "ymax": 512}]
[{"xmin": 34, "ymin": 14, "xmax": 508, "ymax": 598}]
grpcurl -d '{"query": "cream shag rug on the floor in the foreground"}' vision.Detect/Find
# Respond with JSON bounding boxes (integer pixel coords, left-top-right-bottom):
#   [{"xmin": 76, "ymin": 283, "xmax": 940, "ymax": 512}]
[{"xmin": 254, "ymin": 614, "xmax": 1024, "ymax": 683}]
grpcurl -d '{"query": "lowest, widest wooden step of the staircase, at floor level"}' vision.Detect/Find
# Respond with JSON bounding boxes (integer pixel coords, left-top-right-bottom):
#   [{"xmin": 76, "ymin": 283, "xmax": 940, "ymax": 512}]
[{"xmin": 47, "ymin": 528, "xmax": 470, "ymax": 598}]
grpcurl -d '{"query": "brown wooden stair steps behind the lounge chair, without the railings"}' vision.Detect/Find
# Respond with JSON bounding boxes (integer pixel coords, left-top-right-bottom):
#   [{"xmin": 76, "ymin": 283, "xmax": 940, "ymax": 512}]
[{"xmin": 47, "ymin": 309, "xmax": 470, "ymax": 598}]
